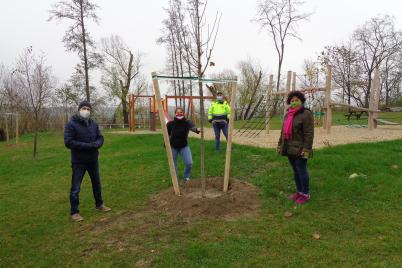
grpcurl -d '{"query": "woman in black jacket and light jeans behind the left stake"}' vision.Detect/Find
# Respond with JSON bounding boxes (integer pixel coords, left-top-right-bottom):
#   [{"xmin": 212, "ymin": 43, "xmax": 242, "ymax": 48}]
[{"xmin": 166, "ymin": 107, "xmax": 200, "ymax": 181}]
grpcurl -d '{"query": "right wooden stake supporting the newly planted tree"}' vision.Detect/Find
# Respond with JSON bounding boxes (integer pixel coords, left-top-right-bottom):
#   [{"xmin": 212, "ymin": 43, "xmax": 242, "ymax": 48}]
[{"xmin": 223, "ymin": 78, "xmax": 237, "ymax": 192}]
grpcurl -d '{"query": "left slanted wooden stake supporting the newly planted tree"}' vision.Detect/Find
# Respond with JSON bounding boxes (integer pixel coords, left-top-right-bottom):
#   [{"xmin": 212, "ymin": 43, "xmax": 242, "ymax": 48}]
[{"xmin": 152, "ymin": 72, "xmax": 180, "ymax": 195}]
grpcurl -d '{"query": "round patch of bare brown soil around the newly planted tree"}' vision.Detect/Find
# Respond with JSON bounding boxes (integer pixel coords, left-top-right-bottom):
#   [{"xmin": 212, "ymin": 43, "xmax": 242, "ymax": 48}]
[{"xmin": 150, "ymin": 178, "xmax": 261, "ymax": 220}]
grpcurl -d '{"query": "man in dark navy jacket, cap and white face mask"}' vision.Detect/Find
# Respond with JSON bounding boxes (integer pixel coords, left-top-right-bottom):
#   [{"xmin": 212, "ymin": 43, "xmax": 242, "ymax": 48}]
[{"xmin": 64, "ymin": 101, "xmax": 111, "ymax": 221}]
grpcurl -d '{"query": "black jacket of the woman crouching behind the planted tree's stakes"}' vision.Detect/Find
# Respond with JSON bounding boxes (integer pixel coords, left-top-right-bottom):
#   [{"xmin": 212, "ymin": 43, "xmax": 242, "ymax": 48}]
[{"xmin": 166, "ymin": 117, "xmax": 199, "ymax": 149}]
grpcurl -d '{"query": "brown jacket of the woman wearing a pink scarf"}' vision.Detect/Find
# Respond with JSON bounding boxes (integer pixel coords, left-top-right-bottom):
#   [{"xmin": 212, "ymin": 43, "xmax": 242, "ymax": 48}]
[{"xmin": 278, "ymin": 107, "xmax": 314, "ymax": 157}]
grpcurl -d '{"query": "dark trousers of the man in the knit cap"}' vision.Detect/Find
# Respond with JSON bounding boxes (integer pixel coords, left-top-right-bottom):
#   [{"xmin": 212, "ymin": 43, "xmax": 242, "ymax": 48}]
[{"xmin": 70, "ymin": 161, "xmax": 103, "ymax": 215}]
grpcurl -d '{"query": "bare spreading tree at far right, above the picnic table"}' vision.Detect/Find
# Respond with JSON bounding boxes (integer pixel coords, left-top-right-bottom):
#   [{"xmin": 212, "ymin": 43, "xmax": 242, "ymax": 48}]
[{"xmin": 353, "ymin": 15, "xmax": 402, "ymax": 107}]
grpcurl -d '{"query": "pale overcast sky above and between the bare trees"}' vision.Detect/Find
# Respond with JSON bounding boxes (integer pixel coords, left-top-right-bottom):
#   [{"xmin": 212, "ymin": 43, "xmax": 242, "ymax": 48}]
[{"xmin": 0, "ymin": 0, "xmax": 402, "ymax": 89}]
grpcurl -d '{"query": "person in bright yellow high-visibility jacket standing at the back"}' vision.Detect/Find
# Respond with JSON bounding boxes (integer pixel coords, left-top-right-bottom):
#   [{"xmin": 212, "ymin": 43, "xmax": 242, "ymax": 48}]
[{"xmin": 208, "ymin": 91, "xmax": 230, "ymax": 151}]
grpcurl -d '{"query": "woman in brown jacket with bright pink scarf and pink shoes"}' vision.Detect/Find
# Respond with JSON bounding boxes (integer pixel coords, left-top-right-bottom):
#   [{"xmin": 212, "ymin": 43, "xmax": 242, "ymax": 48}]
[{"xmin": 277, "ymin": 91, "xmax": 314, "ymax": 204}]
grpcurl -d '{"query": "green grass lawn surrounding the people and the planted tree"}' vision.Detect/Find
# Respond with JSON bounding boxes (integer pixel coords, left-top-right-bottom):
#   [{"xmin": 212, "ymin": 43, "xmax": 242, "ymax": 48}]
[{"xmin": 0, "ymin": 133, "xmax": 402, "ymax": 267}]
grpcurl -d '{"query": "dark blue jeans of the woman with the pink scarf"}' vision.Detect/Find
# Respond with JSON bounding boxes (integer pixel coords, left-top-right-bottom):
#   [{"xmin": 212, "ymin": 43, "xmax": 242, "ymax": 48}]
[{"xmin": 288, "ymin": 156, "xmax": 310, "ymax": 194}]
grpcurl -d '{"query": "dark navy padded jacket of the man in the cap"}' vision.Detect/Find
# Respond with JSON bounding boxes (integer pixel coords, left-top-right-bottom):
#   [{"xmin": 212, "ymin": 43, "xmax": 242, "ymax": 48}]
[{"xmin": 64, "ymin": 114, "xmax": 103, "ymax": 164}]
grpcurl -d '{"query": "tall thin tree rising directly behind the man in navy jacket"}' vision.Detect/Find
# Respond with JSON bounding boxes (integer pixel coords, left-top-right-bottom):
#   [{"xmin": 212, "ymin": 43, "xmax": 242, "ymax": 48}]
[{"xmin": 49, "ymin": 0, "xmax": 101, "ymax": 101}]
